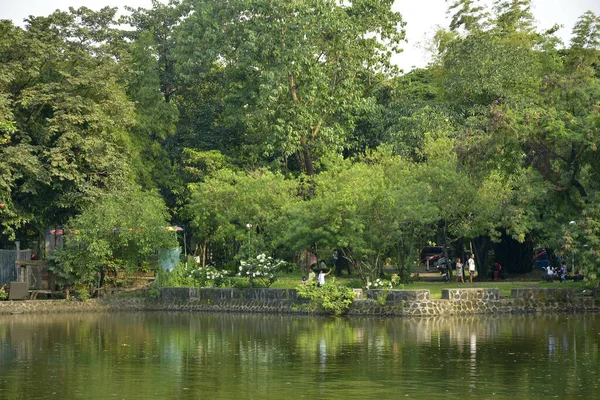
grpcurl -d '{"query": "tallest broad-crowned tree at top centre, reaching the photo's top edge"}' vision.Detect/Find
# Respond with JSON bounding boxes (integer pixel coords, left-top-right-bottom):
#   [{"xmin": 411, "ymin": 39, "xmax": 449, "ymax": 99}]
[{"xmin": 176, "ymin": 0, "xmax": 404, "ymax": 175}]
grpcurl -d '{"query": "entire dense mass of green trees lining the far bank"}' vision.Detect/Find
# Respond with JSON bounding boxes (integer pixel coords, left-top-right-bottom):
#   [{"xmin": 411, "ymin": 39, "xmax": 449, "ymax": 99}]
[{"xmin": 0, "ymin": 0, "xmax": 600, "ymax": 284}]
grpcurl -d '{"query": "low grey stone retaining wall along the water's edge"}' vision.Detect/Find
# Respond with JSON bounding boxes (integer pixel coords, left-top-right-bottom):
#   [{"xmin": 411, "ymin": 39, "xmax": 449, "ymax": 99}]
[{"xmin": 0, "ymin": 288, "xmax": 600, "ymax": 317}]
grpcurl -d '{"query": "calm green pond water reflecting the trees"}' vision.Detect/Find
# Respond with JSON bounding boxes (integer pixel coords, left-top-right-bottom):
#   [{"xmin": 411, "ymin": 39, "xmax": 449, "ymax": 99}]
[{"xmin": 0, "ymin": 313, "xmax": 600, "ymax": 400}]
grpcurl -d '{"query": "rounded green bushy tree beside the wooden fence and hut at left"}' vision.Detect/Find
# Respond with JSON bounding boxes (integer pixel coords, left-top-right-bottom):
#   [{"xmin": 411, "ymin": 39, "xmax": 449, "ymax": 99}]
[{"xmin": 52, "ymin": 189, "xmax": 177, "ymax": 285}]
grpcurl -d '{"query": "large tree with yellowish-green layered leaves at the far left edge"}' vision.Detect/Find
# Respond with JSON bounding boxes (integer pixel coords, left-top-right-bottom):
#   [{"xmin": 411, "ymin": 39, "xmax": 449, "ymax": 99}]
[{"xmin": 0, "ymin": 8, "xmax": 133, "ymax": 244}]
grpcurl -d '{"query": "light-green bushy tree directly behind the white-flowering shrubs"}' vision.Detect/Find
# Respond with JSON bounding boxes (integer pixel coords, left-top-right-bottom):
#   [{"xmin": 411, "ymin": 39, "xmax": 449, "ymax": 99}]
[{"xmin": 185, "ymin": 166, "xmax": 300, "ymax": 264}]
